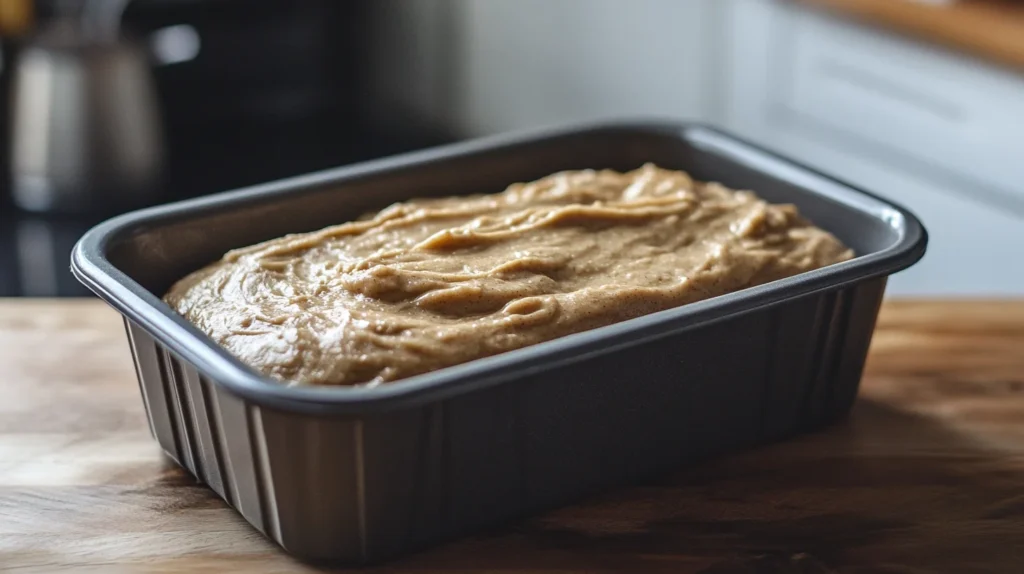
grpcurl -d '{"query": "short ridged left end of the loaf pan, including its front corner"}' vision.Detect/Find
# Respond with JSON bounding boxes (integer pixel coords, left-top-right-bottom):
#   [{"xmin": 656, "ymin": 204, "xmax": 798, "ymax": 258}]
[{"xmin": 125, "ymin": 320, "xmax": 367, "ymax": 562}]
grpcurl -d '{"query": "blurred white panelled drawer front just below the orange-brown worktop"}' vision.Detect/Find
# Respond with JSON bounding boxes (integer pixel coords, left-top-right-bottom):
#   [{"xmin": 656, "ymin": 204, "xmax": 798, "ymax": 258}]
[{"xmin": 773, "ymin": 5, "xmax": 1024, "ymax": 212}]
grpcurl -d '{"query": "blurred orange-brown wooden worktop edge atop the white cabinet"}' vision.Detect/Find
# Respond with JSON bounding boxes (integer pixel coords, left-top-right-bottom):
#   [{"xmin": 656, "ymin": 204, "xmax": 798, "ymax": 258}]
[{"xmin": 794, "ymin": 0, "xmax": 1024, "ymax": 70}]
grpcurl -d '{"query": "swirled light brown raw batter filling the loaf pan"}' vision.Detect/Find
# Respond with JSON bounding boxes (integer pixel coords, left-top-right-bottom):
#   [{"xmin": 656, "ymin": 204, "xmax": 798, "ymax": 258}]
[{"xmin": 165, "ymin": 165, "xmax": 853, "ymax": 385}]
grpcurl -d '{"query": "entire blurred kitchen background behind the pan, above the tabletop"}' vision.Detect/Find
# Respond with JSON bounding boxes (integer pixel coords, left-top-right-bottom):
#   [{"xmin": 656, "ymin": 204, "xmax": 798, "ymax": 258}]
[{"xmin": 0, "ymin": 0, "xmax": 1024, "ymax": 297}]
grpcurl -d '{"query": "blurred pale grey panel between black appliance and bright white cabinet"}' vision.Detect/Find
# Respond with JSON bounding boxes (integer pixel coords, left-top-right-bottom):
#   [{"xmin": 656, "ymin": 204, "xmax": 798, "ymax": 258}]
[{"xmin": 368, "ymin": 0, "xmax": 722, "ymax": 135}]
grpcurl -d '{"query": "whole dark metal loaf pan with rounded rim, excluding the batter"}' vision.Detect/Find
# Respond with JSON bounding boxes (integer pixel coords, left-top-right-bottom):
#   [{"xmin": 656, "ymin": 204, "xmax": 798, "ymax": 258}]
[{"xmin": 72, "ymin": 122, "xmax": 927, "ymax": 563}]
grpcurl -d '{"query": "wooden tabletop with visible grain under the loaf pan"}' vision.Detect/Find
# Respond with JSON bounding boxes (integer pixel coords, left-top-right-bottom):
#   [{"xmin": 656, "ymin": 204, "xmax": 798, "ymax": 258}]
[{"xmin": 0, "ymin": 300, "xmax": 1024, "ymax": 574}]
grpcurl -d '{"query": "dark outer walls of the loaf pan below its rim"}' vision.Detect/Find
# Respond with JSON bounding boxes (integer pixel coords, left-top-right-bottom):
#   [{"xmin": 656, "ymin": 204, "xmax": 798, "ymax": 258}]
[{"xmin": 119, "ymin": 278, "xmax": 886, "ymax": 563}]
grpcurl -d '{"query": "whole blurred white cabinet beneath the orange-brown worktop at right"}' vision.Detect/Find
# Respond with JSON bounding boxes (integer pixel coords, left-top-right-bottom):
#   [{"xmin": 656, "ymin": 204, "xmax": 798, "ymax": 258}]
[{"xmin": 723, "ymin": 0, "xmax": 1024, "ymax": 296}]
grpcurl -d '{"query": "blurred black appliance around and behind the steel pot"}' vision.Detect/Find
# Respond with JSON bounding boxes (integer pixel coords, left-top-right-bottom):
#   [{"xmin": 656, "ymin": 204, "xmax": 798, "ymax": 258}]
[{"xmin": 0, "ymin": 0, "xmax": 451, "ymax": 297}]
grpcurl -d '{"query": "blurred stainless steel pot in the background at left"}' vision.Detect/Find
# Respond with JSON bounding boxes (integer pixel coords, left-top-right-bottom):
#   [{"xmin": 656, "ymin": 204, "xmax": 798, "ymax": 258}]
[{"xmin": 11, "ymin": 0, "xmax": 164, "ymax": 212}]
